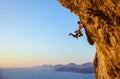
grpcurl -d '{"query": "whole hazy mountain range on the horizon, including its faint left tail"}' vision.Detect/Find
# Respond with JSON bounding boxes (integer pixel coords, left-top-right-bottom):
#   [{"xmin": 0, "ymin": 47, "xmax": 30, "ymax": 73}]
[{"xmin": 35, "ymin": 62, "xmax": 94, "ymax": 73}]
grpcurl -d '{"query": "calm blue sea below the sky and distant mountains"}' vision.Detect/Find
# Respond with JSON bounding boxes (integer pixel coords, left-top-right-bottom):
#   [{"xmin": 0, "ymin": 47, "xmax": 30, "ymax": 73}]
[{"xmin": 0, "ymin": 68, "xmax": 95, "ymax": 79}]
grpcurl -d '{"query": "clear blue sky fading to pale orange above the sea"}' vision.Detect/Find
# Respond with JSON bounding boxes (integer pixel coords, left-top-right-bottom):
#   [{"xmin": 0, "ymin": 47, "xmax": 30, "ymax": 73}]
[{"xmin": 0, "ymin": 0, "xmax": 96, "ymax": 67}]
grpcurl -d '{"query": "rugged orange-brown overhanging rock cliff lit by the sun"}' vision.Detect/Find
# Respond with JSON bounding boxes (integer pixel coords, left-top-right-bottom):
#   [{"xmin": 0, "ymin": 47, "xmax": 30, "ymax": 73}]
[{"xmin": 58, "ymin": 0, "xmax": 120, "ymax": 79}]
